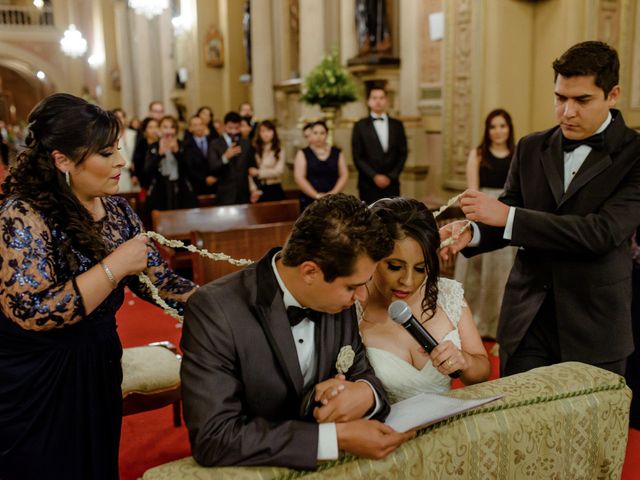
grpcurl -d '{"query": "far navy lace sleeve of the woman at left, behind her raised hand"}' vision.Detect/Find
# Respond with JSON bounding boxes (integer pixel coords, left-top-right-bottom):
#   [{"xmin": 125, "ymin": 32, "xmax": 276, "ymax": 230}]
[{"xmin": 110, "ymin": 197, "xmax": 197, "ymax": 314}]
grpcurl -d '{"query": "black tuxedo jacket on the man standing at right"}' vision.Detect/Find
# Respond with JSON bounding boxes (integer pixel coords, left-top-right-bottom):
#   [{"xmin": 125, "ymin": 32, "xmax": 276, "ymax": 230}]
[{"xmin": 463, "ymin": 110, "xmax": 640, "ymax": 363}]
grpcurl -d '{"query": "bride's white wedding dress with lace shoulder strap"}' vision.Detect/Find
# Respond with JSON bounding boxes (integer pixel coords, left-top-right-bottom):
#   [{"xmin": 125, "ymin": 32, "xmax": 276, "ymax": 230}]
[{"xmin": 366, "ymin": 278, "xmax": 467, "ymax": 403}]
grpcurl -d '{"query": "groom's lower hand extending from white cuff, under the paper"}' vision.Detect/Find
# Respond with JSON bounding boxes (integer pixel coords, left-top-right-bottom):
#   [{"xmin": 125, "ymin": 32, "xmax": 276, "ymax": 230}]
[{"xmin": 336, "ymin": 420, "xmax": 416, "ymax": 460}]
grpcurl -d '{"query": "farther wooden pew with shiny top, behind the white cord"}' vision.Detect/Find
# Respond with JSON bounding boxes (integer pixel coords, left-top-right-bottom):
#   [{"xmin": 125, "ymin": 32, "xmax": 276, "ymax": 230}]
[{"xmin": 151, "ymin": 200, "xmax": 300, "ymax": 270}]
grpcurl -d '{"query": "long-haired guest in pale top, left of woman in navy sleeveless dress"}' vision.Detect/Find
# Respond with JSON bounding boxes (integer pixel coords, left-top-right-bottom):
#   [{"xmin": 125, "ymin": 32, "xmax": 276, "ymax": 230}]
[{"xmin": 249, "ymin": 120, "xmax": 285, "ymax": 202}]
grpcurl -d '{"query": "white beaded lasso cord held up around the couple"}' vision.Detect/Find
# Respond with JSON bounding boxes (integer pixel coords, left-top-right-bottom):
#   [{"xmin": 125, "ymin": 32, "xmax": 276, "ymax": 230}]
[{"xmin": 138, "ymin": 194, "xmax": 470, "ymax": 322}]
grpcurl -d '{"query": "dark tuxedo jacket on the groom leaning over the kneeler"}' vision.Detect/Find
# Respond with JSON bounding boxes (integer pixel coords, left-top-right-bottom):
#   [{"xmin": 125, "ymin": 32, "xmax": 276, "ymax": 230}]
[{"xmin": 181, "ymin": 249, "xmax": 389, "ymax": 469}]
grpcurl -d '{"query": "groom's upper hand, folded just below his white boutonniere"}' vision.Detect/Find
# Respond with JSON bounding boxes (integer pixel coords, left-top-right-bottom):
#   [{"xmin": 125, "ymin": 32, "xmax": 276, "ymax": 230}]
[{"xmin": 313, "ymin": 375, "xmax": 375, "ymax": 423}]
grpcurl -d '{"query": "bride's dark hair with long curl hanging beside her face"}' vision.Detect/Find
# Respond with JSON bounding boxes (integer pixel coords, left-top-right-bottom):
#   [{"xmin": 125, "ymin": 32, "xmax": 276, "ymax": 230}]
[{"xmin": 370, "ymin": 197, "xmax": 440, "ymax": 321}]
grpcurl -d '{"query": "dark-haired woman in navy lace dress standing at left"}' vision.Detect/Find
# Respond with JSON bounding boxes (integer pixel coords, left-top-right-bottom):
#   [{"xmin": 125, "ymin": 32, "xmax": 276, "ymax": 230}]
[{"xmin": 0, "ymin": 94, "xmax": 196, "ymax": 480}]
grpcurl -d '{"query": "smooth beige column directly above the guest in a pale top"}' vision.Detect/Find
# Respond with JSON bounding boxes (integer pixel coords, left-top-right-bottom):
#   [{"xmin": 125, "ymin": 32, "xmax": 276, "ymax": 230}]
[{"xmin": 251, "ymin": 0, "xmax": 275, "ymax": 119}]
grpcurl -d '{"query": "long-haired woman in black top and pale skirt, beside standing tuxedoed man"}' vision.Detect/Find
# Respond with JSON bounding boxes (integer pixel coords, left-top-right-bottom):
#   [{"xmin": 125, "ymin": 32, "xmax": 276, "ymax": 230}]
[{"xmin": 455, "ymin": 108, "xmax": 516, "ymax": 339}]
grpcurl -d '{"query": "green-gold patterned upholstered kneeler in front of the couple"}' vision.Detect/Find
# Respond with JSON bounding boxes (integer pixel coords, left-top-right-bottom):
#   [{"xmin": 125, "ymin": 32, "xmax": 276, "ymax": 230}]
[{"xmin": 142, "ymin": 362, "xmax": 631, "ymax": 480}]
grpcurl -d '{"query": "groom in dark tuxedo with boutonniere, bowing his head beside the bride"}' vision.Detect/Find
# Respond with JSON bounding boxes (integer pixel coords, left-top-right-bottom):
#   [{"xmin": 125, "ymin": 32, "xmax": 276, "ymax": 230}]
[{"xmin": 181, "ymin": 194, "xmax": 412, "ymax": 469}]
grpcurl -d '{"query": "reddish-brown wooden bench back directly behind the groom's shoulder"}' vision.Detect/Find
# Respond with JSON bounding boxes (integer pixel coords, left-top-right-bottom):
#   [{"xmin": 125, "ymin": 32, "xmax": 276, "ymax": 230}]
[{"xmin": 192, "ymin": 221, "xmax": 294, "ymax": 285}]
